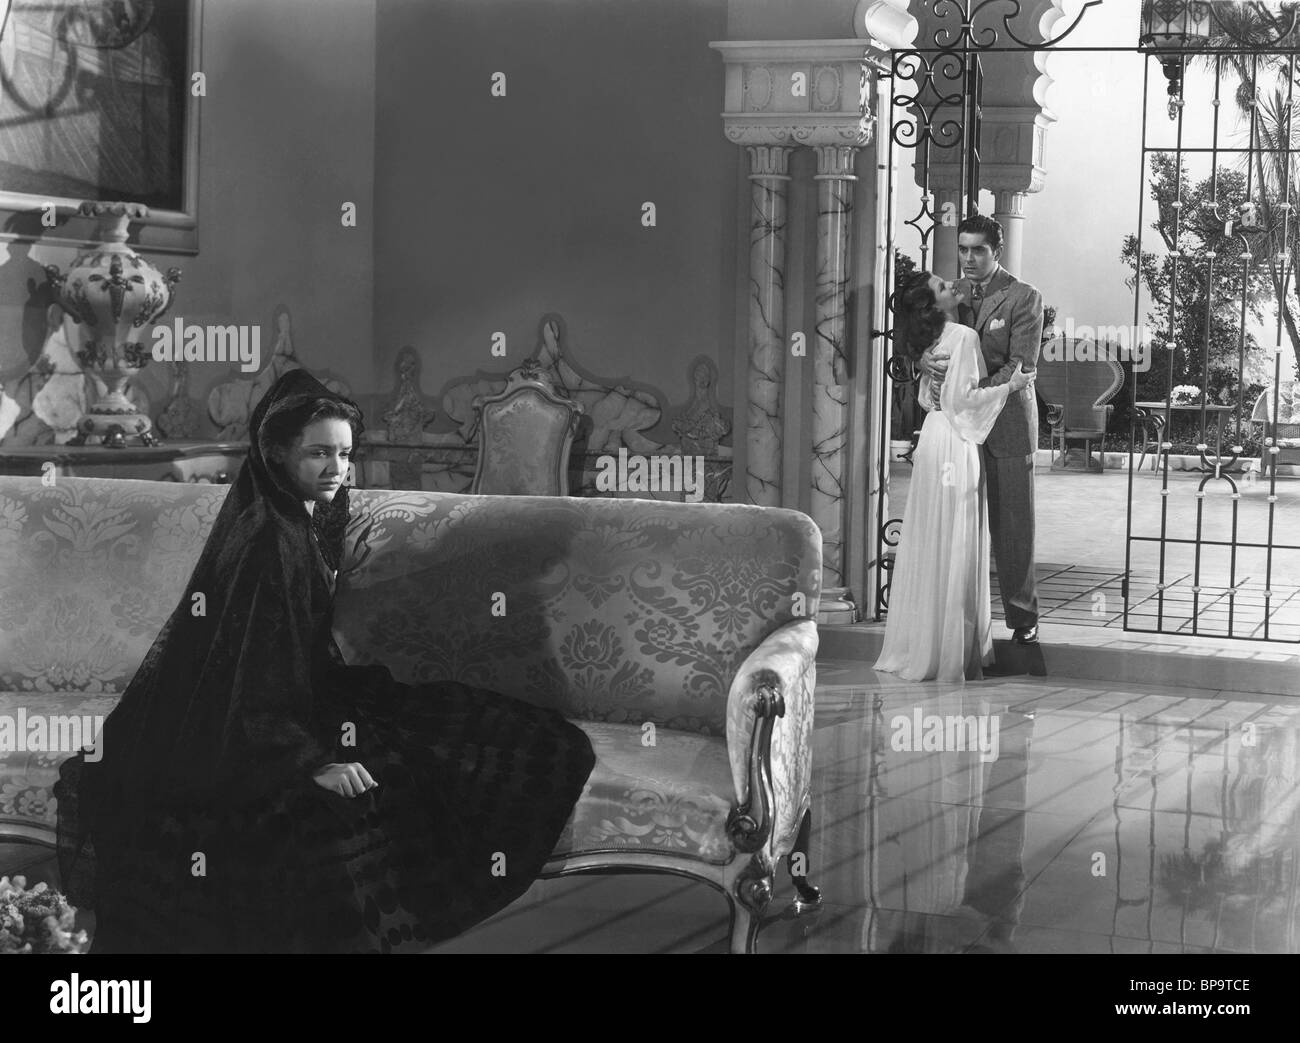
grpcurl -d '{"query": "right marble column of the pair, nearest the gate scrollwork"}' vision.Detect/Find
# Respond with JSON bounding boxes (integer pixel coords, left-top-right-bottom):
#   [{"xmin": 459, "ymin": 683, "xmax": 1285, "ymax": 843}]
[{"xmin": 811, "ymin": 144, "xmax": 858, "ymax": 623}]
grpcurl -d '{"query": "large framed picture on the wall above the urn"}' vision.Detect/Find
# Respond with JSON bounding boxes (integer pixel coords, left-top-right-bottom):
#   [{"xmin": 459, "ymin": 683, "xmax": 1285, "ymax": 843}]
[{"xmin": 0, "ymin": 0, "xmax": 203, "ymax": 254}]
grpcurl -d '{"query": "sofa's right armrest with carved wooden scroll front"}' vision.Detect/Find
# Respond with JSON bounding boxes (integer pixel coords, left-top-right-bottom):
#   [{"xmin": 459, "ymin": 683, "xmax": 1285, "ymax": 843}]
[{"xmin": 727, "ymin": 619, "xmax": 818, "ymax": 858}]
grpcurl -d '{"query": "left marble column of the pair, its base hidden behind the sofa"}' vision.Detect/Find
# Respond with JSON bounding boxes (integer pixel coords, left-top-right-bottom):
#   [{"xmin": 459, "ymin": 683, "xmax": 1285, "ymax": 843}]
[{"xmin": 745, "ymin": 146, "xmax": 792, "ymax": 507}]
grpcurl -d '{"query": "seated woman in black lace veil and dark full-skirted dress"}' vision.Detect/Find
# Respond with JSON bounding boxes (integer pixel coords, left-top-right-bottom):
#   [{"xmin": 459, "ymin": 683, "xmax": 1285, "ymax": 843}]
[{"xmin": 55, "ymin": 369, "xmax": 594, "ymax": 953}]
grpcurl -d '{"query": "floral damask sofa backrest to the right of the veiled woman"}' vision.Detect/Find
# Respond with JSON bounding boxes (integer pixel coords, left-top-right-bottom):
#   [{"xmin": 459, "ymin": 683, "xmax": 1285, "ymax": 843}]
[{"xmin": 334, "ymin": 490, "xmax": 820, "ymax": 736}]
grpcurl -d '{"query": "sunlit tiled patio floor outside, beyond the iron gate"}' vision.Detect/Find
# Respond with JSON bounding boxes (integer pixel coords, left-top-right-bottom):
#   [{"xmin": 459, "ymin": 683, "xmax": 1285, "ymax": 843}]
[{"xmin": 889, "ymin": 462, "xmax": 1300, "ymax": 641}]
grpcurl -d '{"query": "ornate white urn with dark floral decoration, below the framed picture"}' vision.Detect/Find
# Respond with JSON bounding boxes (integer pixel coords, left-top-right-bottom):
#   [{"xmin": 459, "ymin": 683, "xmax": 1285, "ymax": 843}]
[{"xmin": 46, "ymin": 203, "xmax": 181, "ymax": 447}]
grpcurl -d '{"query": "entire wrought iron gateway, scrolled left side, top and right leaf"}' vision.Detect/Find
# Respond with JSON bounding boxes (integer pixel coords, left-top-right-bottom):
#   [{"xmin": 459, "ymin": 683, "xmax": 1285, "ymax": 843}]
[{"xmin": 872, "ymin": 0, "xmax": 1300, "ymax": 641}]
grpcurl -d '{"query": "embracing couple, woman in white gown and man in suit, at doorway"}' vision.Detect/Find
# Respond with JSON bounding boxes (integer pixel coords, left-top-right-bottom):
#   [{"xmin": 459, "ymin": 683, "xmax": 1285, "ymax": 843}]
[{"xmin": 875, "ymin": 215, "xmax": 1043, "ymax": 681}]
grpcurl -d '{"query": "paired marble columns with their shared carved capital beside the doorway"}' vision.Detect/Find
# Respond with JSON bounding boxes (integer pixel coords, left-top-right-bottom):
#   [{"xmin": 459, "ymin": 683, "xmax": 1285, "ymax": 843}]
[{"xmin": 710, "ymin": 36, "xmax": 917, "ymax": 623}]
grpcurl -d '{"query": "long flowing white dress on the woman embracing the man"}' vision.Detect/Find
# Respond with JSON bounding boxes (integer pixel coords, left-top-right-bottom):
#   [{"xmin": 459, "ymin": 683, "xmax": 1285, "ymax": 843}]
[{"xmin": 875, "ymin": 323, "xmax": 1009, "ymax": 681}]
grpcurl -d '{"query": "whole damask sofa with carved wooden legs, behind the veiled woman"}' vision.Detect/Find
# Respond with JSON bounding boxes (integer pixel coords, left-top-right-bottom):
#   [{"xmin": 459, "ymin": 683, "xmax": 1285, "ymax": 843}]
[{"xmin": 0, "ymin": 477, "xmax": 820, "ymax": 952}]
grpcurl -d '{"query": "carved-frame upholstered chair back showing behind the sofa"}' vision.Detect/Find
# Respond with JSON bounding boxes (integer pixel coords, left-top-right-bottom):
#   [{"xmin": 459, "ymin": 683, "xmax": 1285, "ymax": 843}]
[{"xmin": 469, "ymin": 359, "xmax": 582, "ymax": 495}]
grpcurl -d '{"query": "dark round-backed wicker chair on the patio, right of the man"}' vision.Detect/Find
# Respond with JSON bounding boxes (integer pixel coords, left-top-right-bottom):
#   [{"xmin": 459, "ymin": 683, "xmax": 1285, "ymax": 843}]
[{"xmin": 1036, "ymin": 337, "xmax": 1125, "ymax": 471}]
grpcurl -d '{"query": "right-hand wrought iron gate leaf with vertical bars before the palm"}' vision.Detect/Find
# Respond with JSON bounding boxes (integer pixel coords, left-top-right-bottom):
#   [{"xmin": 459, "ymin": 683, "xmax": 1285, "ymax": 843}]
[{"xmin": 1123, "ymin": 12, "xmax": 1300, "ymax": 641}]
